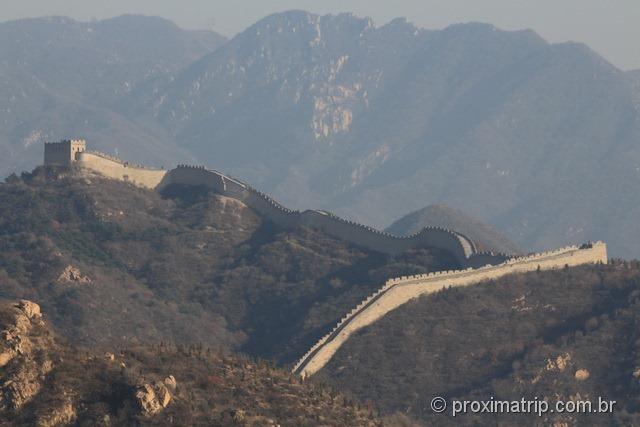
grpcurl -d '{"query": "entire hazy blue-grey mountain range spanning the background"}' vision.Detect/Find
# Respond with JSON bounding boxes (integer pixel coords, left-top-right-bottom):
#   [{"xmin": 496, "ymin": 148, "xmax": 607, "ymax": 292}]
[{"xmin": 0, "ymin": 10, "xmax": 640, "ymax": 256}]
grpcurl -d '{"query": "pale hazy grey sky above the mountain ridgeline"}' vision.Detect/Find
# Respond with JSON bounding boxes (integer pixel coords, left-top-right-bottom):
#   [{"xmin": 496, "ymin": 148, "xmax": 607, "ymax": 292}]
[{"xmin": 5, "ymin": 0, "xmax": 640, "ymax": 69}]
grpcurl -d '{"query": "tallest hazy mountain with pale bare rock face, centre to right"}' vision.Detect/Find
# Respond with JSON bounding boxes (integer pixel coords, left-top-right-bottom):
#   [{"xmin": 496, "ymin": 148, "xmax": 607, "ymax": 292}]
[{"xmin": 135, "ymin": 12, "xmax": 640, "ymax": 255}]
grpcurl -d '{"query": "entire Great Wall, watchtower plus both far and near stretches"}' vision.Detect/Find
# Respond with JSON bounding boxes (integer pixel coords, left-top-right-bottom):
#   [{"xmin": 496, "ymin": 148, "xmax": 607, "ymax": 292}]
[{"xmin": 45, "ymin": 140, "xmax": 607, "ymax": 377}]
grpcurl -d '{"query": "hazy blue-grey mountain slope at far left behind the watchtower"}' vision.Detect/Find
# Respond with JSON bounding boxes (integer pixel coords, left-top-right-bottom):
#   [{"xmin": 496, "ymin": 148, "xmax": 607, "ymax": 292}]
[{"xmin": 0, "ymin": 16, "xmax": 225, "ymax": 176}]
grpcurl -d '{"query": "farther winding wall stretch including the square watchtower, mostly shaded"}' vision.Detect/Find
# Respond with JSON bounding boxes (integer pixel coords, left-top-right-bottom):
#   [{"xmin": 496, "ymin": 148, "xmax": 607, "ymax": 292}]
[{"xmin": 45, "ymin": 140, "xmax": 509, "ymax": 268}]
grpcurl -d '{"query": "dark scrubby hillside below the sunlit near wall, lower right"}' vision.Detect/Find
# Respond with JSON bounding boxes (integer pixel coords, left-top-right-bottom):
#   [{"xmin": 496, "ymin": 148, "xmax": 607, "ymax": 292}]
[{"xmin": 319, "ymin": 262, "xmax": 640, "ymax": 425}]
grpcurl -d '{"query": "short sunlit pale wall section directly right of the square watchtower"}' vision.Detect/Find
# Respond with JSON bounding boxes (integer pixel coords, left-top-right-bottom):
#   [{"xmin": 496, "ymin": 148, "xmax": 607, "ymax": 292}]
[{"xmin": 76, "ymin": 151, "xmax": 167, "ymax": 188}]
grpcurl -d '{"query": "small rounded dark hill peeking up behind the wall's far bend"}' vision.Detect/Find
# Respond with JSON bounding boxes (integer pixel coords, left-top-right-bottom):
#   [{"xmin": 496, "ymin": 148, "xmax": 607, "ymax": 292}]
[{"xmin": 385, "ymin": 205, "xmax": 521, "ymax": 254}]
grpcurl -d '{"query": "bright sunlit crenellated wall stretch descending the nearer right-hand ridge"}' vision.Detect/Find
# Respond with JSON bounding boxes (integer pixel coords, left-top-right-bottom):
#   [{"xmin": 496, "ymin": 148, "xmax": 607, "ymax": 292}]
[{"xmin": 293, "ymin": 242, "xmax": 607, "ymax": 377}]
